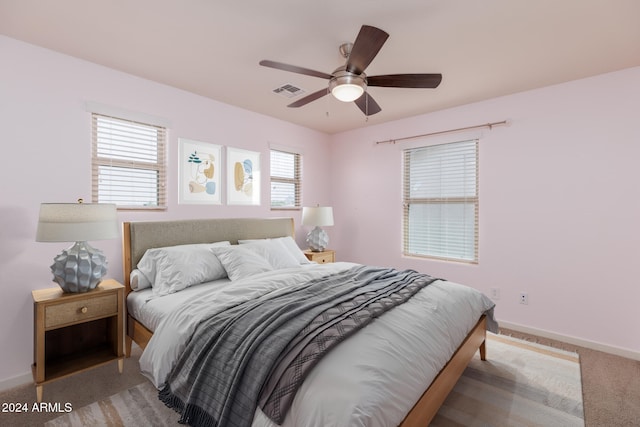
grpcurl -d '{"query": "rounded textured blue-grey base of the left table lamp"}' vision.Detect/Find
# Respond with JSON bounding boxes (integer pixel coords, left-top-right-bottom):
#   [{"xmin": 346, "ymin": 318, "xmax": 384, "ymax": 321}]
[{"xmin": 51, "ymin": 242, "xmax": 107, "ymax": 293}]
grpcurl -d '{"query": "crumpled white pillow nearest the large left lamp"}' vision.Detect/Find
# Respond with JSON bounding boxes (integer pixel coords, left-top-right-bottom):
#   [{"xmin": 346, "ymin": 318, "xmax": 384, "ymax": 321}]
[{"xmin": 138, "ymin": 241, "xmax": 229, "ymax": 297}]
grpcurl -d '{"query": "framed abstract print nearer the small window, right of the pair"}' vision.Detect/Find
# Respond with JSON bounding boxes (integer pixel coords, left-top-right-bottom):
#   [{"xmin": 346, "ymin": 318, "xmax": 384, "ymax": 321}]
[{"xmin": 227, "ymin": 147, "xmax": 260, "ymax": 205}]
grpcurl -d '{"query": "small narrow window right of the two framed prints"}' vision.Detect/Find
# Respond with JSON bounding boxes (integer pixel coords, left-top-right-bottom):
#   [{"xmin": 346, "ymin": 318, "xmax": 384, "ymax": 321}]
[{"xmin": 271, "ymin": 150, "xmax": 302, "ymax": 209}]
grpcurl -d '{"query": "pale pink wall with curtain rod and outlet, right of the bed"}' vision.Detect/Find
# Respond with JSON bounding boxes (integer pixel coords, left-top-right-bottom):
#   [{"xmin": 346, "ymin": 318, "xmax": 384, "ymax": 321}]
[{"xmin": 330, "ymin": 68, "xmax": 640, "ymax": 354}]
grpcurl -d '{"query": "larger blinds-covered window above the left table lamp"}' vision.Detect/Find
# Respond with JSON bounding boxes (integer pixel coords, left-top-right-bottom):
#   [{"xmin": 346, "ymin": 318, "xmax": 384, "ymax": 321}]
[{"xmin": 91, "ymin": 113, "xmax": 166, "ymax": 209}]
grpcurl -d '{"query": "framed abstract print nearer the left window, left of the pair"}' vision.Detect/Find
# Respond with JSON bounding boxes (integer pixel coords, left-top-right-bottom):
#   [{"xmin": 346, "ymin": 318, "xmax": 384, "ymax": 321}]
[{"xmin": 178, "ymin": 138, "xmax": 222, "ymax": 205}]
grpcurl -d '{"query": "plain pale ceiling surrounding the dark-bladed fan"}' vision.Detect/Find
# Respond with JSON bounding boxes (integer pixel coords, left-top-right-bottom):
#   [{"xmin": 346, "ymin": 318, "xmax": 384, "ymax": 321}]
[{"xmin": 0, "ymin": 0, "xmax": 640, "ymax": 133}]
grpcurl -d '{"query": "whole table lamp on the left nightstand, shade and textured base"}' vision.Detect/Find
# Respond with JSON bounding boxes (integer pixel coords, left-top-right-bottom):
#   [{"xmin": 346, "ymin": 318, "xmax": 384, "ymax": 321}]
[{"xmin": 36, "ymin": 199, "xmax": 118, "ymax": 292}]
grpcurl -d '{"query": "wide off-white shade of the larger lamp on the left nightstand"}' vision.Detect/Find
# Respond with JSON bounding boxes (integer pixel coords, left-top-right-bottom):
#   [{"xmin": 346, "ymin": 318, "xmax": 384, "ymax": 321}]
[{"xmin": 36, "ymin": 203, "xmax": 118, "ymax": 242}]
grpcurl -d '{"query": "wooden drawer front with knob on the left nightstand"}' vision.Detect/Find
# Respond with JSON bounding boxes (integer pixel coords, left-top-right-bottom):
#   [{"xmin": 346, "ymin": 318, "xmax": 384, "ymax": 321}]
[{"xmin": 44, "ymin": 293, "xmax": 118, "ymax": 329}]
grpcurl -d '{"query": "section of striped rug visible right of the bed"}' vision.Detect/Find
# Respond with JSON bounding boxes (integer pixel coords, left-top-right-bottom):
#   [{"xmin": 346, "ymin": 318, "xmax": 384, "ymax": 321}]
[{"xmin": 431, "ymin": 334, "xmax": 584, "ymax": 427}]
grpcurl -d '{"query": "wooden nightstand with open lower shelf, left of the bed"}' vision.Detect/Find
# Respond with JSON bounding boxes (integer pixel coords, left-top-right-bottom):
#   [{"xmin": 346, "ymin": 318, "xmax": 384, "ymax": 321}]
[{"xmin": 31, "ymin": 279, "xmax": 124, "ymax": 403}]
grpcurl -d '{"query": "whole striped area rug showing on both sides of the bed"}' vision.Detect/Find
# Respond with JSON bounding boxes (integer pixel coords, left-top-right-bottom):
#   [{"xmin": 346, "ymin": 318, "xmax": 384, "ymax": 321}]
[{"xmin": 45, "ymin": 334, "xmax": 584, "ymax": 427}]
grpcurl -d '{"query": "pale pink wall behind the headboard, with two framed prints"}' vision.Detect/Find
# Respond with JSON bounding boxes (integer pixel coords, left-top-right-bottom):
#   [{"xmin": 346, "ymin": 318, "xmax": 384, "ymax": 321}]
[{"xmin": 0, "ymin": 36, "xmax": 330, "ymax": 383}]
